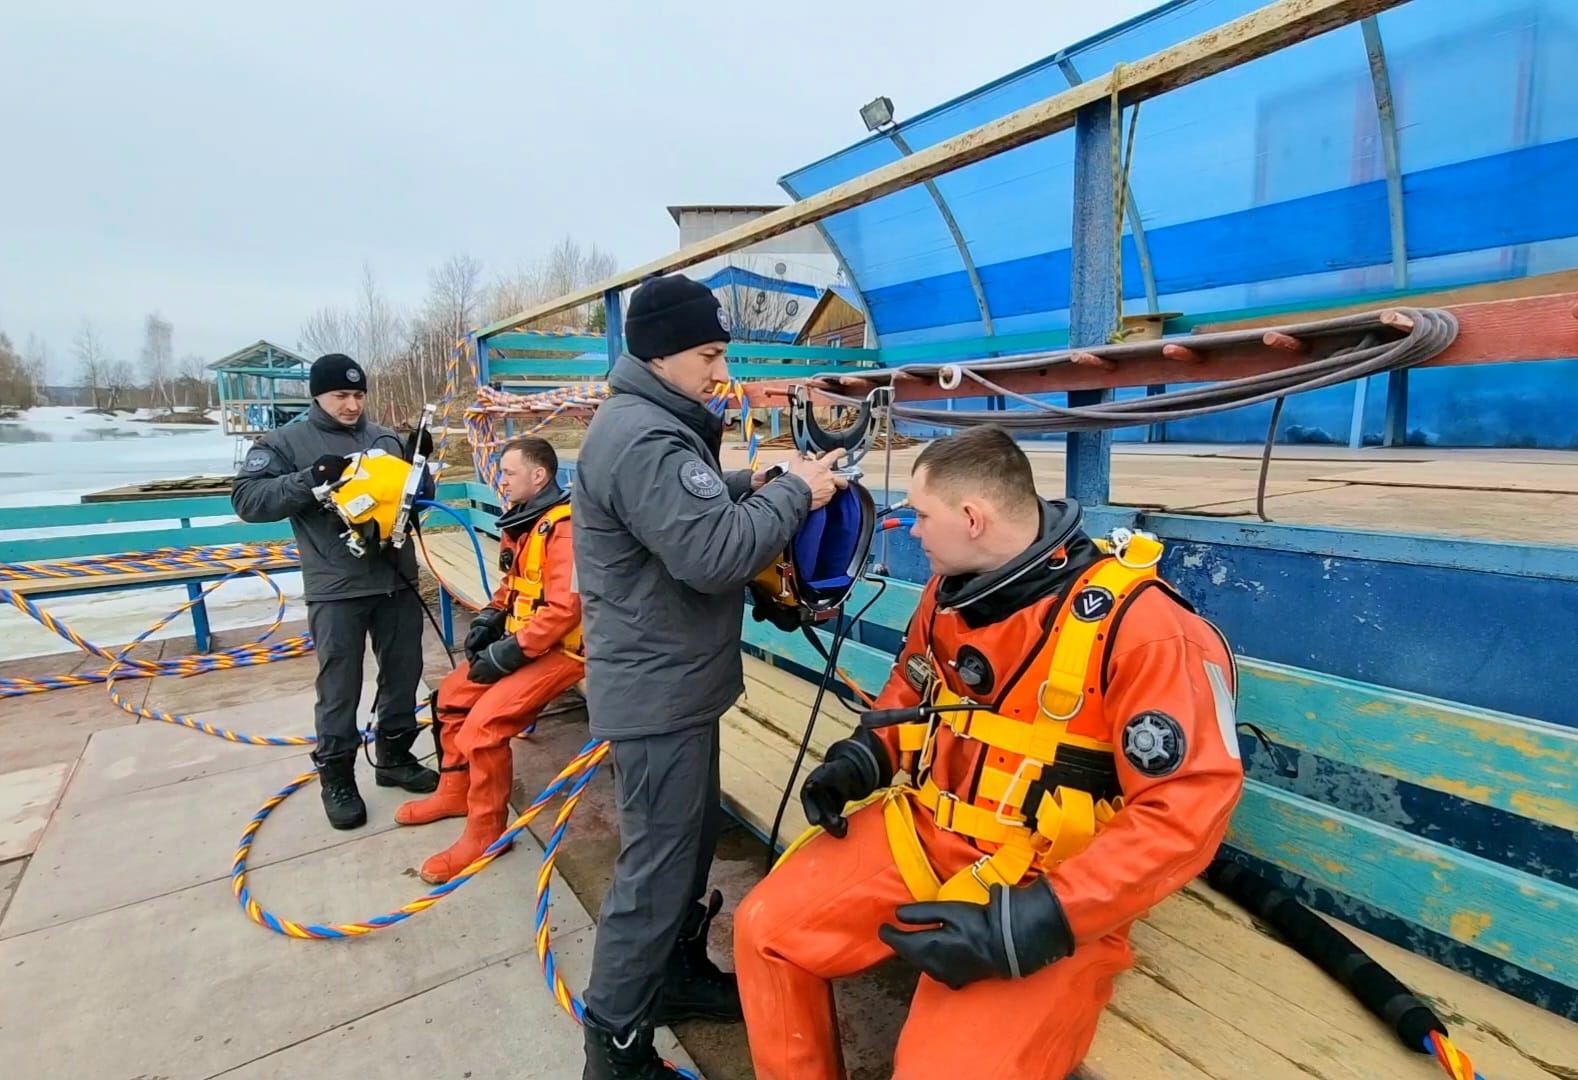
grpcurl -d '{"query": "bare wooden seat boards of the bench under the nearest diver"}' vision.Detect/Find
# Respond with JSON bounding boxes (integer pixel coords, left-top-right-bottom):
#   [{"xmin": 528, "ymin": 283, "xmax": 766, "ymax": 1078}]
[{"xmin": 723, "ymin": 657, "xmax": 1578, "ymax": 1080}]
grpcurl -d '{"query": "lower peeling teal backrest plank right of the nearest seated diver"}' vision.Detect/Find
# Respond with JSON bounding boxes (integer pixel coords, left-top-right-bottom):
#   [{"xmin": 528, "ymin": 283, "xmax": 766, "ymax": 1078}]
[{"xmin": 1228, "ymin": 780, "xmax": 1578, "ymax": 987}]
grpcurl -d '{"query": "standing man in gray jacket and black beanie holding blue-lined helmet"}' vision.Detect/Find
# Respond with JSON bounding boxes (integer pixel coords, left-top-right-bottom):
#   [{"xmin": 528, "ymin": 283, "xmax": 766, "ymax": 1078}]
[{"xmin": 571, "ymin": 275, "xmax": 844, "ymax": 1080}]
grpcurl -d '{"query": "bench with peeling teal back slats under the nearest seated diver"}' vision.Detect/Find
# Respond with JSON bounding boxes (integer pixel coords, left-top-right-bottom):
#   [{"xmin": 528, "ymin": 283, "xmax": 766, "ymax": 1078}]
[{"xmin": 723, "ymin": 579, "xmax": 1578, "ymax": 1080}]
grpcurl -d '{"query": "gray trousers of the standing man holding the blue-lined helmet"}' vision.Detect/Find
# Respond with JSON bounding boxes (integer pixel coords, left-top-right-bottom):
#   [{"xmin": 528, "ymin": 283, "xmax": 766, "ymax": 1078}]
[{"xmin": 584, "ymin": 720, "xmax": 723, "ymax": 1033}]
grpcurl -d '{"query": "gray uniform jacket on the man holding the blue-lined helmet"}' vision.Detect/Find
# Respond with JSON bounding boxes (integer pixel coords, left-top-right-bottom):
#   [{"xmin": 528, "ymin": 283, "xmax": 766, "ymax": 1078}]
[{"xmin": 571, "ymin": 355, "xmax": 811, "ymax": 739}]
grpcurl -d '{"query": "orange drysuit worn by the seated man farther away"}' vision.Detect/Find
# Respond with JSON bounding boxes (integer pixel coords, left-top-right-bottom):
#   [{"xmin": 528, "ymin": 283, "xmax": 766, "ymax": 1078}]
[{"xmin": 396, "ymin": 496, "xmax": 585, "ymax": 884}]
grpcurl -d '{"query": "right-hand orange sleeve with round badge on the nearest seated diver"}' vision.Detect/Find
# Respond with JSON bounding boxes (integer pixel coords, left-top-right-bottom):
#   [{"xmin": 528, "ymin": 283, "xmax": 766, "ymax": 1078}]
[{"xmin": 1048, "ymin": 589, "xmax": 1243, "ymax": 944}]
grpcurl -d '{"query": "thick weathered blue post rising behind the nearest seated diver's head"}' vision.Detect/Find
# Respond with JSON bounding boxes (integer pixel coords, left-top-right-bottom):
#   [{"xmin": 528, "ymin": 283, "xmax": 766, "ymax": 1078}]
[{"xmin": 1065, "ymin": 101, "xmax": 1119, "ymax": 507}]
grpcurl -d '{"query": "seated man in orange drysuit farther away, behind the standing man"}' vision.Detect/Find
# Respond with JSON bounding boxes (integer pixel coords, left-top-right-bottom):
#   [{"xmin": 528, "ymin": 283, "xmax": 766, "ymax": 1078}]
[{"xmin": 395, "ymin": 436, "xmax": 585, "ymax": 884}]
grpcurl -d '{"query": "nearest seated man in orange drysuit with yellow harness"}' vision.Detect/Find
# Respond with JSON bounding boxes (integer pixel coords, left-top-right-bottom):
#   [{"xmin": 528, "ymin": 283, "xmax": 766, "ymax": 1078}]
[{"xmin": 734, "ymin": 428, "xmax": 1243, "ymax": 1080}]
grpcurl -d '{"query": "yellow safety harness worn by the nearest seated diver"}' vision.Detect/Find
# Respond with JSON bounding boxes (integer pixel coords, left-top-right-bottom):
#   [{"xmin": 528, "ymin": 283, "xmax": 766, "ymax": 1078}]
[{"xmin": 881, "ymin": 534, "xmax": 1161, "ymax": 903}]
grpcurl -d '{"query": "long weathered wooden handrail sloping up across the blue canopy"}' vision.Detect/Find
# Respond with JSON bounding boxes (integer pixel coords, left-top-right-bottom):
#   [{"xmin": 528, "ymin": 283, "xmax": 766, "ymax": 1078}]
[{"xmin": 478, "ymin": 0, "xmax": 1401, "ymax": 336}]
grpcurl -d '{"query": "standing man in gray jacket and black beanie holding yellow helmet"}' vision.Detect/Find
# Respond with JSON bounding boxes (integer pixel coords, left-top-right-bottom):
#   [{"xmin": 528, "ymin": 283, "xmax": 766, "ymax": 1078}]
[{"xmin": 230, "ymin": 352, "xmax": 439, "ymax": 829}]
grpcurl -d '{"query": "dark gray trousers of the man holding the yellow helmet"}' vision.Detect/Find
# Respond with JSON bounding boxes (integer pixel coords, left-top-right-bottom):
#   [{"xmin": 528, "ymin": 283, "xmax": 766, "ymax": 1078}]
[{"xmin": 306, "ymin": 589, "xmax": 423, "ymax": 758}]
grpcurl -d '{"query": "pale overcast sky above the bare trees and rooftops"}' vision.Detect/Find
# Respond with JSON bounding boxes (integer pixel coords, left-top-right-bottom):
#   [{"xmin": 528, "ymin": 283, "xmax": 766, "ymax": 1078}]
[{"xmin": 0, "ymin": 0, "xmax": 1155, "ymax": 381}]
